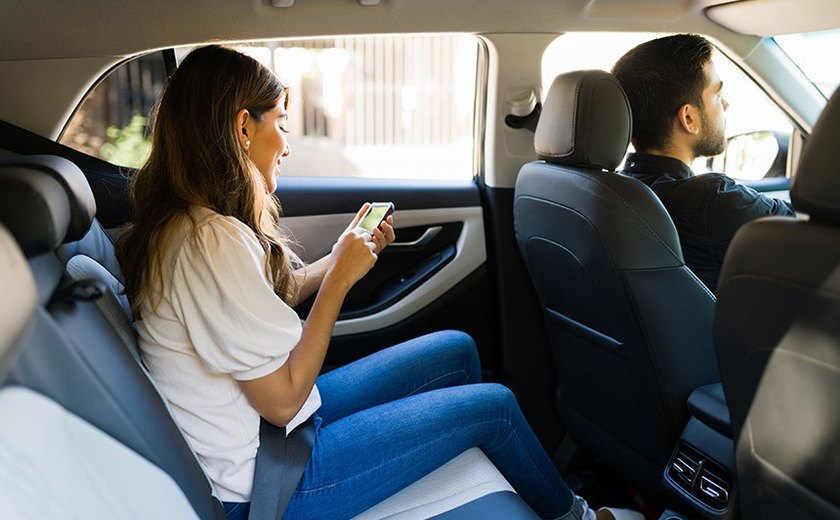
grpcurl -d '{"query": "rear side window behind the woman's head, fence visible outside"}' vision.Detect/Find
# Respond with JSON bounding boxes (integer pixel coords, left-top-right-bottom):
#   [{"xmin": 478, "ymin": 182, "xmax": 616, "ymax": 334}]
[{"xmin": 61, "ymin": 34, "xmax": 480, "ymax": 179}]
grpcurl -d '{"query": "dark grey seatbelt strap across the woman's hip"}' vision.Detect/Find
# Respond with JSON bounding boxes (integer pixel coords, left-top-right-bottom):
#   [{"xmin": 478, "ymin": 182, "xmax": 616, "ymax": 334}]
[{"xmin": 248, "ymin": 417, "xmax": 315, "ymax": 520}]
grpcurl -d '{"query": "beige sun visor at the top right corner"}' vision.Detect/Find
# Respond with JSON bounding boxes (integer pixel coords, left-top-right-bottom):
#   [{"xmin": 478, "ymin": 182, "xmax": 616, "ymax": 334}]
[{"xmin": 706, "ymin": 0, "xmax": 840, "ymax": 36}]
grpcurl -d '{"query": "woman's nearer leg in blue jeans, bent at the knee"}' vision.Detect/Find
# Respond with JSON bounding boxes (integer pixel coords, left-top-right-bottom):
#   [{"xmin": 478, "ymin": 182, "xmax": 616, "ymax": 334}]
[{"xmin": 286, "ymin": 384, "xmax": 572, "ymax": 519}]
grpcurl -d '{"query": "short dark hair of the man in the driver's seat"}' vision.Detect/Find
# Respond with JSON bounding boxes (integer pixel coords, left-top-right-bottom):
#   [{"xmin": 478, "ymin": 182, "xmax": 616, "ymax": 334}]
[{"xmin": 612, "ymin": 34, "xmax": 714, "ymax": 151}]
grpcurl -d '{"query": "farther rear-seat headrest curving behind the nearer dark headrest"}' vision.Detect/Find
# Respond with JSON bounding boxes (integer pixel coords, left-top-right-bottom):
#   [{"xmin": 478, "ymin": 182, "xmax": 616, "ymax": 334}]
[{"xmin": 0, "ymin": 155, "xmax": 96, "ymax": 242}]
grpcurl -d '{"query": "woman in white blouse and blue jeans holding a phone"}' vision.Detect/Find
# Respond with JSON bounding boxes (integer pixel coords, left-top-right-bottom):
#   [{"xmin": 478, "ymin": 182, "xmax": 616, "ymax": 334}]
[{"xmin": 118, "ymin": 45, "xmax": 640, "ymax": 519}]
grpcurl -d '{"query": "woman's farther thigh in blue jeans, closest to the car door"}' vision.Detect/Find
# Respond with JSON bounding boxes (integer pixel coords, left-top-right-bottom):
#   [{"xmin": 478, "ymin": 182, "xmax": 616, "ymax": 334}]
[{"xmin": 318, "ymin": 331, "xmax": 481, "ymax": 424}]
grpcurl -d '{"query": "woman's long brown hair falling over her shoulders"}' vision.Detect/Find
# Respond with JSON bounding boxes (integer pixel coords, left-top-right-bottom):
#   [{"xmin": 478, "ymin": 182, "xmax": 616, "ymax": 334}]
[{"xmin": 117, "ymin": 45, "xmax": 299, "ymax": 318}]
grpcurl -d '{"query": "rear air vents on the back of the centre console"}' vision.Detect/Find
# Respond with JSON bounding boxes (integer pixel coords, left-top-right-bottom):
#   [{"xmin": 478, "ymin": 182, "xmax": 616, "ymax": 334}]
[{"xmin": 668, "ymin": 444, "xmax": 732, "ymax": 510}]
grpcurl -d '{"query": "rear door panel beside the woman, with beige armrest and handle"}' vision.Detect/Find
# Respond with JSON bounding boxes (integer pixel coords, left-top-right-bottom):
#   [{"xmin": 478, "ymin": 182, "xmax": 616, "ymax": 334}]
[{"xmin": 276, "ymin": 177, "xmax": 499, "ymax": 371}]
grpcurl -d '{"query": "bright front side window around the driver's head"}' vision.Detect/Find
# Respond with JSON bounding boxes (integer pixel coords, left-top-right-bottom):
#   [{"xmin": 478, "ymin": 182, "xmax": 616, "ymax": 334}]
[{"xmin": 542, "ymin": 33, "xmax": 793, "ymax": 180}]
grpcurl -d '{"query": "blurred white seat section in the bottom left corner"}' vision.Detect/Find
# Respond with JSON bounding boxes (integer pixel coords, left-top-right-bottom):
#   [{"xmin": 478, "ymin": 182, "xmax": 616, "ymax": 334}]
[{"xmin": 0, "ymin": 387, "xmax": 197, "ymax": 520}]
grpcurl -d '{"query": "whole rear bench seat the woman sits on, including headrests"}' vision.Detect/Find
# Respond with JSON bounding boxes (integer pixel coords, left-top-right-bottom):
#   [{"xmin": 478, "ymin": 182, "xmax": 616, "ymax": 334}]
[{"xmin": 0, "ymin": 156, "xmax": 536, "ymax": 519}]
